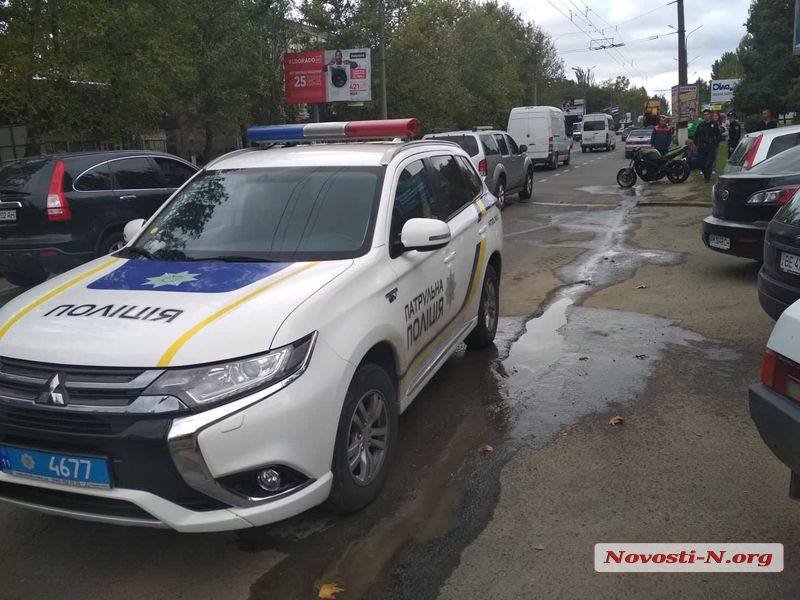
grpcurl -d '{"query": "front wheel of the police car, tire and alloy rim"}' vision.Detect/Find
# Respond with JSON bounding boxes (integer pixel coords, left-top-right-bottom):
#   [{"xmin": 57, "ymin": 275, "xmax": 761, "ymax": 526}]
[{"xmin": 327, "ymin": 363, "xmax": 398, "ymax": 514}]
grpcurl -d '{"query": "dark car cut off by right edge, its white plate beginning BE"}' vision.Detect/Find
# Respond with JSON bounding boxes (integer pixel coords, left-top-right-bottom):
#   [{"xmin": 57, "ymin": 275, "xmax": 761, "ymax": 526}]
[{"xmin": 758, "ymin": 195, "xmax": 800, "ymax": 320}]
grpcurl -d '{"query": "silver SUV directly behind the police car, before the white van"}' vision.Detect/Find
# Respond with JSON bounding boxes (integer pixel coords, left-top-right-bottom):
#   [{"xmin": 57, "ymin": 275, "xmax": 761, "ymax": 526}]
[{"xmin": 424, "ymin": 128, "xmax": 533, "ymax": 208}]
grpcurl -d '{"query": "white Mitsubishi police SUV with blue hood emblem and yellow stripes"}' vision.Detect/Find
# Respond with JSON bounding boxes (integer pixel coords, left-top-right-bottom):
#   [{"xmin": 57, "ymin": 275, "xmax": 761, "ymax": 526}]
[{"xmin": 0, "ymin": 119, "xmax": 502, "ymax": 531}]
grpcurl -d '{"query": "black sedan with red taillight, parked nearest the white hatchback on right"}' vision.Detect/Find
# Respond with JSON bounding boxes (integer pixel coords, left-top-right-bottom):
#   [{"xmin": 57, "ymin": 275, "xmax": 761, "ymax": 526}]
[{"xmin": 703, "ymin": 146, "xmax": 800, "ymax": 261}]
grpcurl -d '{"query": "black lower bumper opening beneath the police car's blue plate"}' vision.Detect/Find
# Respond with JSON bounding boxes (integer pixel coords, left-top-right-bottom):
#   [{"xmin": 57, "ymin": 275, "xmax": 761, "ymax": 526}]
[{"xmin": 0, "ymin": 481, "xmax": 158, "ymax": 523}]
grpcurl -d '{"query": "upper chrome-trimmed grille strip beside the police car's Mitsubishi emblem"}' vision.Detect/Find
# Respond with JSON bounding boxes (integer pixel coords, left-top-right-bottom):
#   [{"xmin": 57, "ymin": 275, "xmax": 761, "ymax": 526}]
[{"xmin": 0, "ymin": 358, "xmax": 161, "ymax": 407}]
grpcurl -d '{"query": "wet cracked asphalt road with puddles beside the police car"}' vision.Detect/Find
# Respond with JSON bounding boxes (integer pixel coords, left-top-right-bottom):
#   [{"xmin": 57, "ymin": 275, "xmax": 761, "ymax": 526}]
[{"xmin": 0, "ymin": 146, "xmax": 800, "ymax": 600}]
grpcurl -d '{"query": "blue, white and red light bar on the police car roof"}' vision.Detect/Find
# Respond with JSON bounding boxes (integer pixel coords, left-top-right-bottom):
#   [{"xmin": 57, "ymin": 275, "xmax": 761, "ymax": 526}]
[{"xmin": 247, "ymin": 119, "xmax": 419, "ymax": 144}]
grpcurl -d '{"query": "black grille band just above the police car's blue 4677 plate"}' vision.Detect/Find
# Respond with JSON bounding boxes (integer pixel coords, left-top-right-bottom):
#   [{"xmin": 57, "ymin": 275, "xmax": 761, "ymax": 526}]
[{"xmin": 0, "ymin": 404, "xmax": 135, "ymax": 435}]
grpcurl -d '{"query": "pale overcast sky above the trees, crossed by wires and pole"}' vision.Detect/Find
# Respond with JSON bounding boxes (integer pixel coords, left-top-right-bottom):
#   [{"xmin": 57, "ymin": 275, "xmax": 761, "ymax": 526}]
[{"xmin": 510, "ymin": 0, "xmax": 750, "ymax": 98}]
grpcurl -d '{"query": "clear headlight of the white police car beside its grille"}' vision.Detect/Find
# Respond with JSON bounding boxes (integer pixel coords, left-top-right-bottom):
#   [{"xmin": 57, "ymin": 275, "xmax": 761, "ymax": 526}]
[{"xmin": 143, "ymin": 333, "xmax": 316, "ymax": 408}]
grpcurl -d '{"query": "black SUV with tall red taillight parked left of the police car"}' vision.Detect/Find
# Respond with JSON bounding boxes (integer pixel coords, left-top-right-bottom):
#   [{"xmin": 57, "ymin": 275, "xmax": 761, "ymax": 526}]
[{"xmin": 0, "ymin": 150, "xmax": 197, "ymax": 286}]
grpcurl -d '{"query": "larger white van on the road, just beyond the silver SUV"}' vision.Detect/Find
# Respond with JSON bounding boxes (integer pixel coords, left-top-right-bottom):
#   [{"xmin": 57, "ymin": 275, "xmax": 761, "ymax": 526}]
[{"xmin": 506, "ymin": 106, "xmax": 572, "ymax": 169}]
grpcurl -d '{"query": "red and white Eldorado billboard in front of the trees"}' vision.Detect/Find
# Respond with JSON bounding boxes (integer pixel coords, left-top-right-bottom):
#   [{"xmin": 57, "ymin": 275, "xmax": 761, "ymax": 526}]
[{"xmin": 283, "ymin": 48, "xmax": 372, "ymax": 104}]
